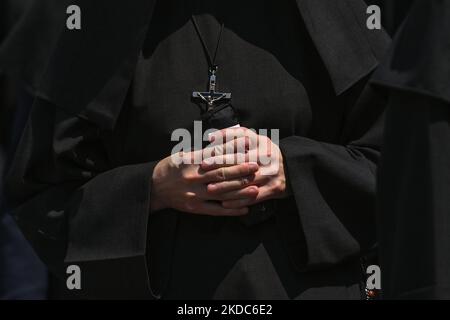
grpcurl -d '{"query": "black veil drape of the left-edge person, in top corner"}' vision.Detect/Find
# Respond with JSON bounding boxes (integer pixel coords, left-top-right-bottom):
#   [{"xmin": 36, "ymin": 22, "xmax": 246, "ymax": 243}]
[{"xmin": 0, "ymin": 0, "xmax": 70, "ymax": 89}]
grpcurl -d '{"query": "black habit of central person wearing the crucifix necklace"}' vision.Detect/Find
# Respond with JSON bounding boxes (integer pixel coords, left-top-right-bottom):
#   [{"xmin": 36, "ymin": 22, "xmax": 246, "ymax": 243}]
[{"xmin": 8, "ymin": 0, "xmax": 389, "ymax": 299}]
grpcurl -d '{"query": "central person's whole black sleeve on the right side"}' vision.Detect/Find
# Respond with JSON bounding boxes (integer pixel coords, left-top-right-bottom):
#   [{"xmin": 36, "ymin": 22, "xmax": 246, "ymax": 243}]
[{"xmin": 280, "ymin": 84, "xmax": 385, "ymax": 270}]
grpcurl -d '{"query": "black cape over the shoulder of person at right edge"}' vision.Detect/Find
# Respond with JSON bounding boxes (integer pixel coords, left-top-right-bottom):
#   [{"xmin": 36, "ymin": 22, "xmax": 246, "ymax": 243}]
[{"xmin": 371, "ymin": 0, "xmax": 450, "ymax": 103}]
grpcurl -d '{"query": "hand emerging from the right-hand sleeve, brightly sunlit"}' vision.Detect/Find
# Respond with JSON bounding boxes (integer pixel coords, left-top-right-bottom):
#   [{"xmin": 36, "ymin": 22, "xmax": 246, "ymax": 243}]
[{"xmin": 201, "ymin": 127, "xmax": 289, "ymax": 209}]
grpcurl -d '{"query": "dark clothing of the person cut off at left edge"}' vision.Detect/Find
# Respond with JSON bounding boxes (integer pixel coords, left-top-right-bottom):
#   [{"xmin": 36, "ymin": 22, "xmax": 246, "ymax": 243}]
[{"xmin": 0, "ymin": 0, "xmax": 59, "ymax": 300}]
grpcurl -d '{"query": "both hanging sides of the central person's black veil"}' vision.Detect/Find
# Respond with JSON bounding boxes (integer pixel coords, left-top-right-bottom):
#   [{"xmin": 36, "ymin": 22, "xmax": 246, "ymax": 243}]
[{"xmin": 28, "ymin": 0, "xmax": 389, "ymax": 128}]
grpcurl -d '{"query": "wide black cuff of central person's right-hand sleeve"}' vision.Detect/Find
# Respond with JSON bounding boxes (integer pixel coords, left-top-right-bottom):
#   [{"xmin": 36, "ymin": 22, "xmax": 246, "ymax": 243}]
[{"xmin": 278, "ymin": 136, "xmax": 375, "ymax": 270}]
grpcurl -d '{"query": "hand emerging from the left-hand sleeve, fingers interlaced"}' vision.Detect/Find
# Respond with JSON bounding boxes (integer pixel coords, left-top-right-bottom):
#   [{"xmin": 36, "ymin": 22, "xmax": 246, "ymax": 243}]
[{"xmin": 151, "ymin": 151, "xmax": 259, "ymax": 216}]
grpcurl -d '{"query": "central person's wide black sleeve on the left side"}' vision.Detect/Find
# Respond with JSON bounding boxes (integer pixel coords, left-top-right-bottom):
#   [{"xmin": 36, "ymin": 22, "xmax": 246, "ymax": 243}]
[{"xmin": 7, "ymin": 98, "xmax": 156, "ymax": 297}]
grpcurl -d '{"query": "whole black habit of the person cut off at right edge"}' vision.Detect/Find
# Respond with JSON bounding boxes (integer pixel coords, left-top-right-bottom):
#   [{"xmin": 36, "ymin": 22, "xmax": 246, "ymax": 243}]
[{"xmin": 373, "ymin": 0, "xmax": 450, "ymax": 299}]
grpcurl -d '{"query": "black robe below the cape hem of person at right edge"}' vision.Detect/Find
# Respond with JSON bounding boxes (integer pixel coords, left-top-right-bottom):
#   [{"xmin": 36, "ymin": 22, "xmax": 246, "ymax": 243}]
[{"xmin": 378, "ymin": 91, "xmax": 450, "ymax": 299}]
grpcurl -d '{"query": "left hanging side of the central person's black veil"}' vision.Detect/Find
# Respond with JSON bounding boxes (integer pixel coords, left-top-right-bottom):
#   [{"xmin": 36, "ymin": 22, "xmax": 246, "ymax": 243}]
[{"xmin": 33, "ymin": 0, "xmax": 156, "ymax": 129}]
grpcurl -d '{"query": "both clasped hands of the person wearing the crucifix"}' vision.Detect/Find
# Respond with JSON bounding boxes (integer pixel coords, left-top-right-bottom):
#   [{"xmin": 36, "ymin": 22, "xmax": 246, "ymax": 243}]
[{"xmin": 151, "ymin": 128, "xmax": 289, "ymax": 216}]
